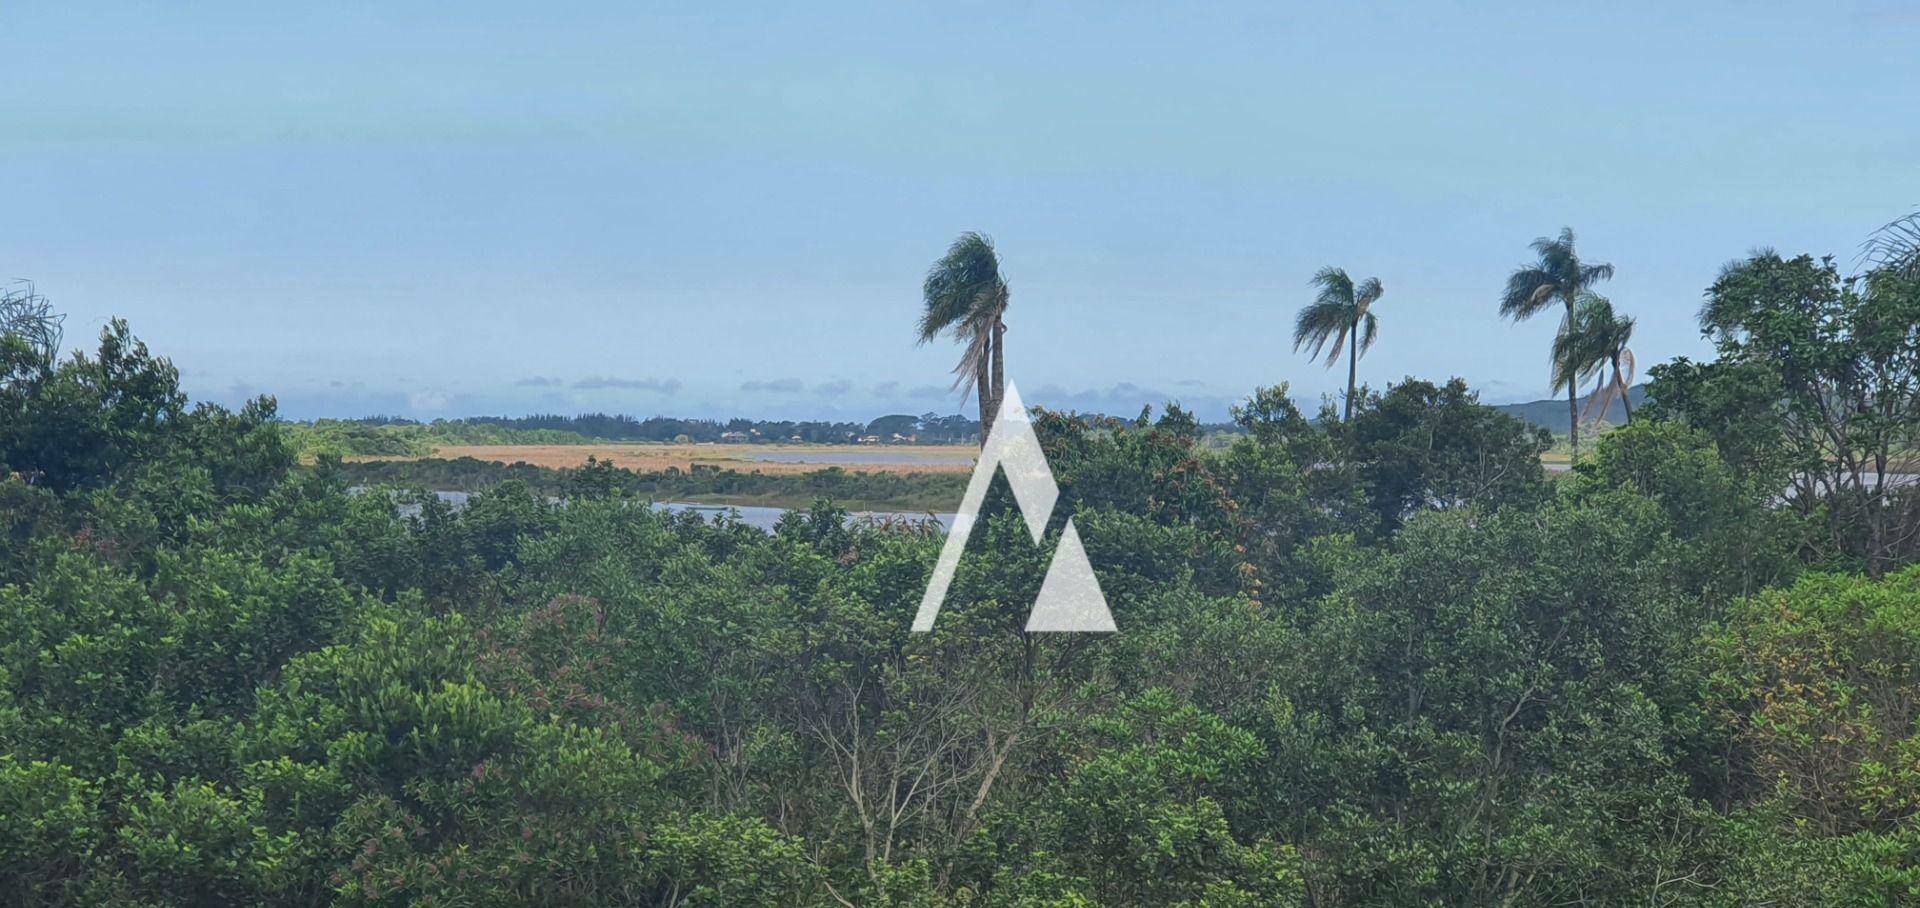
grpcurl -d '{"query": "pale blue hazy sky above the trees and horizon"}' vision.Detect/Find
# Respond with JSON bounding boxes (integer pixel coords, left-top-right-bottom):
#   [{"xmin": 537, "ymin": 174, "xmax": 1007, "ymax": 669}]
[{"xmin": 0, "ymin": 0, "xmax": 1920, "ymax": 420}]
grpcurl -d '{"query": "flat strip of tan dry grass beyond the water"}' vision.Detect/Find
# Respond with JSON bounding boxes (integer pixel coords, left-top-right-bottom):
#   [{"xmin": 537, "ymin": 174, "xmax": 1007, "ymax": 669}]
[{"xmin": 351, "ymin": 443, "xmax": 973, "ymax": 474}]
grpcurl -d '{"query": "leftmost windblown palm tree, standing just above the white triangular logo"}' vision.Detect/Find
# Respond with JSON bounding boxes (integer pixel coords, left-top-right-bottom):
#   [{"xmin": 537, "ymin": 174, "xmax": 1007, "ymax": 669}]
[{"xmin": 920, "ymin": 230, "xmax": 1008, "ymax": 443}]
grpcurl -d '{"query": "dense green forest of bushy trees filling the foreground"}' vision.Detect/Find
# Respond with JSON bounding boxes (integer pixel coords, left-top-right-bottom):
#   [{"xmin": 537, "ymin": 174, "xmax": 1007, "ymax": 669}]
[{"xmin": 0, "ymin": 244, "xmax": 1920, "ymax": 908}]
